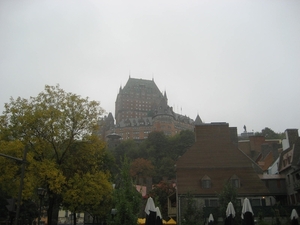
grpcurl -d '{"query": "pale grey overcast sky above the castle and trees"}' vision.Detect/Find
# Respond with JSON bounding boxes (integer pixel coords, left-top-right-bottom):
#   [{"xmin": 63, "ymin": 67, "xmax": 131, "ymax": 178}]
[{"xmin": 0, "ymin": 0, "xmax": 300, "ymax": 133}]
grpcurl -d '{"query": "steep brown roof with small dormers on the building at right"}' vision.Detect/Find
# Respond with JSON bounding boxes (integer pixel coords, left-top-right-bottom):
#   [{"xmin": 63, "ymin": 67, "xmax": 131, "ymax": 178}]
[{"xmin": 176, "ymin": 123, "xmax": 269, "ymax": 196}]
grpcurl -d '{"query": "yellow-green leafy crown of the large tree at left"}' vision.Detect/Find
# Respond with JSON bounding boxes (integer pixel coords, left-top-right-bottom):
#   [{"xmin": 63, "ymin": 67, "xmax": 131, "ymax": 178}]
[{"xmin": 0, "ymin": 85, "xmax": 112, "ymax": 213}]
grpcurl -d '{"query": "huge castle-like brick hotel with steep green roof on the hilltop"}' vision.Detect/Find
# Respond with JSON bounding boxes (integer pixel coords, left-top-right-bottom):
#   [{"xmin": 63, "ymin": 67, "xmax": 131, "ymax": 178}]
[{"xmin": 102, "ymin": 77, "xmax": 202, "ymax": 140}]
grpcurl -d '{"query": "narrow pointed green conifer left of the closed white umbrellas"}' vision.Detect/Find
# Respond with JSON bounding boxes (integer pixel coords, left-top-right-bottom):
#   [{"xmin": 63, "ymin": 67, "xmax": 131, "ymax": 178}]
[{"xmin": 110, "ymin": 158, "xmax": 142, "ymax": 225}]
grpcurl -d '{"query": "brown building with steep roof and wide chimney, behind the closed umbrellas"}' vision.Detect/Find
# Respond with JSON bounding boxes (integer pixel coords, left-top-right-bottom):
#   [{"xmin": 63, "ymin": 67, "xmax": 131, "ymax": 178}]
[{"xmin": 176, "ymin": 123, "xmax": 275, "ymax": 221}]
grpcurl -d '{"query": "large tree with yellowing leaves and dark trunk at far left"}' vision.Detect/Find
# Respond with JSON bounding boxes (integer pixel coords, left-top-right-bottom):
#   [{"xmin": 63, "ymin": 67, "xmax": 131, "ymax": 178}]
[{"xmin": 0, "ymin": 85, "xmax": 108, "ymax": 224}]
